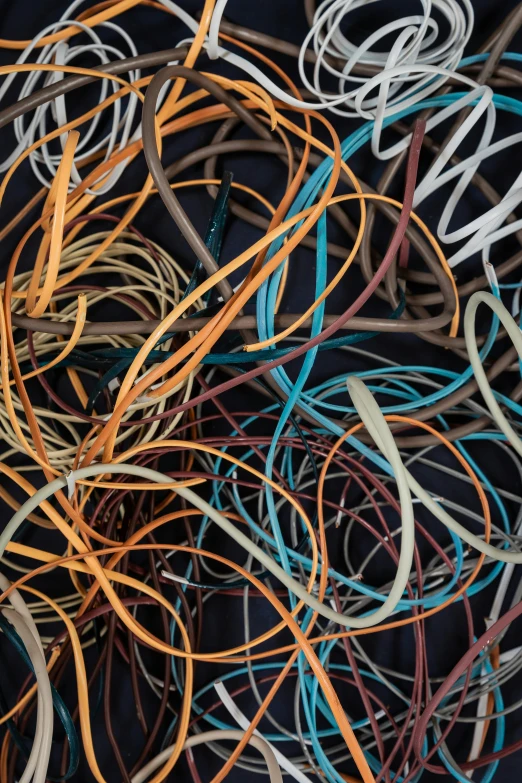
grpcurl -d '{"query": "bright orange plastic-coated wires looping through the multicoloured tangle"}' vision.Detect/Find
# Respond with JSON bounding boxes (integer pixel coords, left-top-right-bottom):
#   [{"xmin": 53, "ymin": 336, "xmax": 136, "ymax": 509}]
[{"xmin": 0, "ymin": 13, "xmax": 484, "ymax": 783}]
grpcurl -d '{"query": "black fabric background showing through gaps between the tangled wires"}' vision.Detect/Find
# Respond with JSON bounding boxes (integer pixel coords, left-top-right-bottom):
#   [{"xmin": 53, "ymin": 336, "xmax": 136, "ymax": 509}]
[{"xmin": 0, "ymin": 0, "xmax": 522, "ymax": 783}]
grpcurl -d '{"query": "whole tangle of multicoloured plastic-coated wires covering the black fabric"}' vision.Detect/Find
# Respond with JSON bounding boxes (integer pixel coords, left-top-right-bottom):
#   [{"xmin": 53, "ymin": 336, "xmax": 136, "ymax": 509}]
[{"xmin": 0, "ymin": 0, "xmax": 522, "ymax": 783}]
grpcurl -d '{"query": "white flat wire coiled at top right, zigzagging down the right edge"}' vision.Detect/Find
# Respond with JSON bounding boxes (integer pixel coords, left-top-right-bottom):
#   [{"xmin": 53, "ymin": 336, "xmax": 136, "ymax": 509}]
[{"xmin": 176, "ymin": 0, "xmax": 522, "ymax": 267}]
